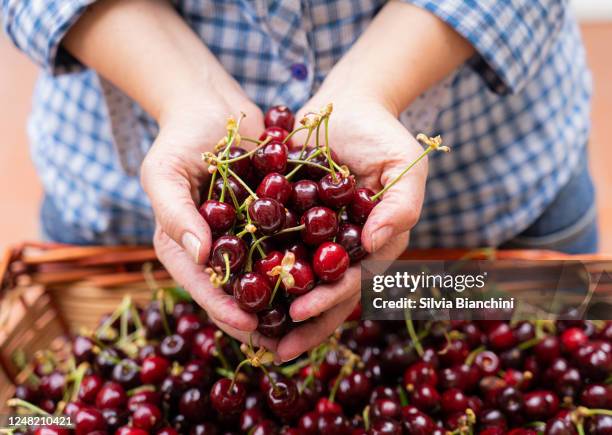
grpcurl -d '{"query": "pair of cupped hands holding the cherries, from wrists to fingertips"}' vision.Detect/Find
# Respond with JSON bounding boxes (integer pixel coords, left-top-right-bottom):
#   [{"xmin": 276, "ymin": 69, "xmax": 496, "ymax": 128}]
[{"xmin": 142, "ymin": 89, "xmax": 427, "ymax": 362}]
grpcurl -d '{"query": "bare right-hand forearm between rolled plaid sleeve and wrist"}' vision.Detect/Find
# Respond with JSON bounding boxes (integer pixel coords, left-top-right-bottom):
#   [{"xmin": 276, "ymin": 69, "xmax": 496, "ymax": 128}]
[{"xmin": 322, "ymin": 1, "xmax": 474, "ymax": 115}]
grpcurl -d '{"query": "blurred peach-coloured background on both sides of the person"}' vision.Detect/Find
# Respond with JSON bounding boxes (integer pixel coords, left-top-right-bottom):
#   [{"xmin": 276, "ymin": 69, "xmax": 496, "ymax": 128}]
[{"xmin": 0, "ymin": 11, "xmax": 612, "ymax": 253}]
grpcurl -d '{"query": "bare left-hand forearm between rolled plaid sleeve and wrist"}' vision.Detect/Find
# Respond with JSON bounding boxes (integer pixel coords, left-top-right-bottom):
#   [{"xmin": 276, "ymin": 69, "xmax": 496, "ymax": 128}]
[{"xmin": 63, "ymin": 0, "xmax": 247, "ymax": 122}]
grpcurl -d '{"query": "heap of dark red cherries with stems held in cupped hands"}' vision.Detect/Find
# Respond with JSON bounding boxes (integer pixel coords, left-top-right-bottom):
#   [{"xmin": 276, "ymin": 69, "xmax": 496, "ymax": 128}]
[{"xmin": 200, "ymin": 104, "xmax": 444, "ymax": 337}]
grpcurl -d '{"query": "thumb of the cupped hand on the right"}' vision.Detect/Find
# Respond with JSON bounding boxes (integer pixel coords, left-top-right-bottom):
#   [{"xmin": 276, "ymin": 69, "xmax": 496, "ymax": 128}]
[{"xmin": 361, "ymin": 150, "xmax": 427, "ymax": 252}]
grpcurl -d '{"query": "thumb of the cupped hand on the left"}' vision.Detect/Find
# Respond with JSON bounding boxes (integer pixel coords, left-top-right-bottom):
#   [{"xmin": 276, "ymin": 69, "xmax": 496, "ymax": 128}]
[{"xmin": 141, "ymin": 143, "xmax": 211, "ymax": 264}]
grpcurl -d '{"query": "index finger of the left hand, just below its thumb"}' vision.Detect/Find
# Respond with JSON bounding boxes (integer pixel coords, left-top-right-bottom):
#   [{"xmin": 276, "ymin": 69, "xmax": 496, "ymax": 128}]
[{"xmin": 153, "ymin": 229, "xmax": 257, "ymax": 332}]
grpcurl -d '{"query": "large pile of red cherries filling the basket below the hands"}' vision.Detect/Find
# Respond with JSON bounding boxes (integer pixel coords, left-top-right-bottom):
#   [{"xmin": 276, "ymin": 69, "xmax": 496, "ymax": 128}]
[{"xmin": 9, "ymin": 297, "xmax": 612, "ymax": 435}]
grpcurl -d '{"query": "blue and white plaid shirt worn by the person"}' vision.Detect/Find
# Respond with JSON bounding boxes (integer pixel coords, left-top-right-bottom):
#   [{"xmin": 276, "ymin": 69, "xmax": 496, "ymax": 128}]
[{"xmin": 2, "ymin": 0, "xmax": 591, "ymax": 247}]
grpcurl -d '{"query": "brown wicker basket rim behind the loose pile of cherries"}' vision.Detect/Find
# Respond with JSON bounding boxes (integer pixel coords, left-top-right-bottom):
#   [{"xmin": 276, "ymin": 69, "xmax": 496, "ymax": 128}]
[{"xmin": 0, "ymin": 243, "xmax": 612, "ymax": 413}]
